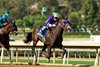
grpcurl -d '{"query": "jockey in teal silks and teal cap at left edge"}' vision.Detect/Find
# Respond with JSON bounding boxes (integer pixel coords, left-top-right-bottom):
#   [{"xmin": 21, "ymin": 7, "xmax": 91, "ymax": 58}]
[{"xmin": 0, "ymin": 12, "xmax": 9, "ymax": 28}]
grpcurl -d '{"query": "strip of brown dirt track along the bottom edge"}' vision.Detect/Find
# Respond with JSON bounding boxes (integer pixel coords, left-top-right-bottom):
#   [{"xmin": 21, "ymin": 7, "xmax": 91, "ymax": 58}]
[{"xmin": 0, "ymin": 64, "xmax": 90, "ymax": 67}]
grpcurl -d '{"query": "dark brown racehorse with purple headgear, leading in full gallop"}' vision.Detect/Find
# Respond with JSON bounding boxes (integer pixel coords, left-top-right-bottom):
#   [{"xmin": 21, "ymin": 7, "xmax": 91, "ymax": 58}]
[{"xmin": 24, "ymin": 19, "xmax": 71, "ymax": 62}]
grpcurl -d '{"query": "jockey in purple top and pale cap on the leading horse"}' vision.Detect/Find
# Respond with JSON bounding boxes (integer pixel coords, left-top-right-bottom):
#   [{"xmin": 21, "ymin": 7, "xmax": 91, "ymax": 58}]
[{"xmin": 42, "ymin": 13, "xmax": 60, "ymax": 34}]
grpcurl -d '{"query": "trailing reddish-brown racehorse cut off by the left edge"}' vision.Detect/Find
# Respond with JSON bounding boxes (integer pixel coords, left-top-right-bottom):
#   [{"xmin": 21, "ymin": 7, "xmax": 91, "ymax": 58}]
[{"xmin": 0, "ymin": 20, "xmax": 18, "ymax": 63}]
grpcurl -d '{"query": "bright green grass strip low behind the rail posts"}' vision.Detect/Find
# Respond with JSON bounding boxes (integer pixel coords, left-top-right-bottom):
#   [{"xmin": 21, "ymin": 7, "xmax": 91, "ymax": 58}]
[{"xmin": 0, "ymin": 58, "xmax": 94, "ymax": 65}]
